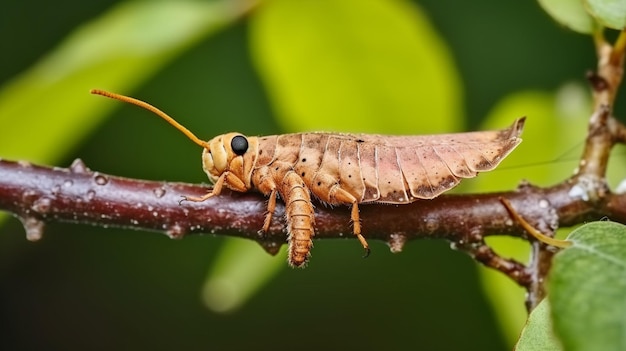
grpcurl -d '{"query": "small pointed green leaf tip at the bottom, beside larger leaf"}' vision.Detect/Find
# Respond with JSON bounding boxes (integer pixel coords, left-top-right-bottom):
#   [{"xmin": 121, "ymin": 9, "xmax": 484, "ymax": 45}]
[{"xmin": 515, "ymin": 299, "xmax": 563, "ymax": 351}]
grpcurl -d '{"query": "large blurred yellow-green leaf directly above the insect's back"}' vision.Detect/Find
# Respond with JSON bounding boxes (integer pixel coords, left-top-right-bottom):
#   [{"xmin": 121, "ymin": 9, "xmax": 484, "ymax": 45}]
[{"xmin": 250, "ymin": 0, "xmax": 463, "ymax": 134}]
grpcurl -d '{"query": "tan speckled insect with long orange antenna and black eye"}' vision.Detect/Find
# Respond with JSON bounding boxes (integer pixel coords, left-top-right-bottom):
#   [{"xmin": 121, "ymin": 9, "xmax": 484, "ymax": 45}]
[{"xmin": 91, "ymin": 90, "xmax": 525, "ymax": 267}]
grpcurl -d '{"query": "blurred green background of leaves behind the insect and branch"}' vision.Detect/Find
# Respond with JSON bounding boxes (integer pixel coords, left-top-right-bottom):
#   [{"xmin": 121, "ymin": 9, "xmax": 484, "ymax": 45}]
[{"xmin": 0, "ymin": 0, "xmax": 612, "ymax": 350}]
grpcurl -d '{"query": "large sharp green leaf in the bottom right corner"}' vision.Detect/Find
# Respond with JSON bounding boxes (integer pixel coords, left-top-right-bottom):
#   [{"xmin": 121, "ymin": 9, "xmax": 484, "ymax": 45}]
[{"xmin": 548, "ymin": 222, "xmax": 626, "ymax": 351}]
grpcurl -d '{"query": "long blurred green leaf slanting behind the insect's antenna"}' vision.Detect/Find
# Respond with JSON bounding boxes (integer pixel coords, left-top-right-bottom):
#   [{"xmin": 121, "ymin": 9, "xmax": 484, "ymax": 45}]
[{"xmin": 0, "ymin": 1, "xmax": 248, "ymax": 163}]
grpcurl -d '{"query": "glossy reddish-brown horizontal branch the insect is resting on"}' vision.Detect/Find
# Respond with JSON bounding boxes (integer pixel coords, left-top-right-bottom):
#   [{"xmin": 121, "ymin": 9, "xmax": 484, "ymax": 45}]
[{"xmin": 0, "ymin": 160, "xmax": 626, "ymax": 288}]
